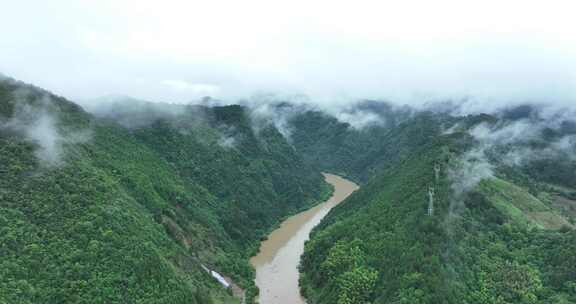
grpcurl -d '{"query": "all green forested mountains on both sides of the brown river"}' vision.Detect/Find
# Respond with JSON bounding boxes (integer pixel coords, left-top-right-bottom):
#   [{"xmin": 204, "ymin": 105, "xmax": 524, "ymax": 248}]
[{"xmin": 0, "ymin": 74, "xmax": 576, "ymax": 304}]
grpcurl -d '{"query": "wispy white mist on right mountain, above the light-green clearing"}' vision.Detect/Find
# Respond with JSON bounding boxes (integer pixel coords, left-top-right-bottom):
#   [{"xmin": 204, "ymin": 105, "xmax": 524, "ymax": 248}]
[{"xmin": 451, "ymin": 107, "xmax": 576, "ymax": 196}]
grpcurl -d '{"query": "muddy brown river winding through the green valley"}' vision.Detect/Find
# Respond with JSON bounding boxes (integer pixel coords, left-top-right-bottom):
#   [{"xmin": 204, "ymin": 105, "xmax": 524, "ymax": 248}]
[{"xmin": 250, "ymin": 174, "xmax": 358, "ymax": 304}]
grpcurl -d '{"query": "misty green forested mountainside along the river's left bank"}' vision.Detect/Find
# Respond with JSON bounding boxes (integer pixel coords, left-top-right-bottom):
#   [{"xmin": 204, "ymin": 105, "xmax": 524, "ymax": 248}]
[{"xmin": 0, "ymin": 79, "xmax": 328, "ymax": 303}]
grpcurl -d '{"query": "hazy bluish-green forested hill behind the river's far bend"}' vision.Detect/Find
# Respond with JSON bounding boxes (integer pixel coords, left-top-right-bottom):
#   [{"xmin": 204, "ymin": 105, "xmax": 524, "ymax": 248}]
[{"xmin": 290, "ymin": 107, "xmax": 449, "ymax": 182}]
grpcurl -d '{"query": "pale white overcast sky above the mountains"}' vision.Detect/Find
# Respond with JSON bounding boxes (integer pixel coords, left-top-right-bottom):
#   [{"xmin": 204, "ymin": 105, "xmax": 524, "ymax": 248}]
[{"xmin": 0, "ymin": 0, "xmax": 576, "ymax": 107}]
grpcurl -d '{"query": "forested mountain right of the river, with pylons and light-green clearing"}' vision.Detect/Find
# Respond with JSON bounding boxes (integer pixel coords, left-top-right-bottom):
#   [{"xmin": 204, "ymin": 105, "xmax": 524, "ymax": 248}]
[{"xmin": 295, "ymin": 108, "xmax": 576, "ymax": 304}]
